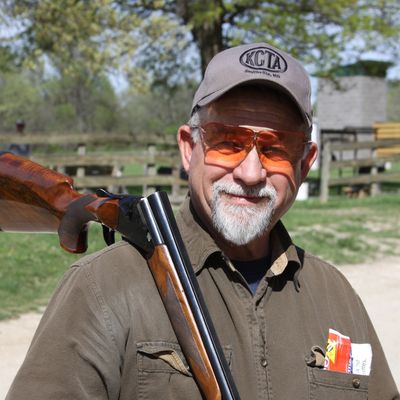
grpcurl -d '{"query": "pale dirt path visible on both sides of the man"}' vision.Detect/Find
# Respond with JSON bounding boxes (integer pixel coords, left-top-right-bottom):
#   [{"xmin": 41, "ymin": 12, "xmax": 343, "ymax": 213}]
[{"xmin": 0, "ymin": 257, "xmax": 400, "ymax": 399}]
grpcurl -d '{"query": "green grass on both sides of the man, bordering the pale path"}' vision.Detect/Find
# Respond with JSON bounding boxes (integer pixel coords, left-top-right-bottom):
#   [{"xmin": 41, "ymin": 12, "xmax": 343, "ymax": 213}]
[{"xmin": 0, "ymin": 195, "xmax": 400, "ymax": 319}]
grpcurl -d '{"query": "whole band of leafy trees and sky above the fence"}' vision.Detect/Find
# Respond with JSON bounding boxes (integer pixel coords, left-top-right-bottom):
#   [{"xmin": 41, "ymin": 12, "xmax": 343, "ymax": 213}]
[{"xmin": 0, "ymin": 0, "xmax": 400, "ymax": 132}]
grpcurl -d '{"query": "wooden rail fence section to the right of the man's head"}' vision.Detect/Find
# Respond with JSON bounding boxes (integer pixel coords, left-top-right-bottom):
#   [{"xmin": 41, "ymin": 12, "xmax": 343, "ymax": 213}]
[{"xmin": 320, "ymin": 138, "xmax": 400, "ymax": 202}]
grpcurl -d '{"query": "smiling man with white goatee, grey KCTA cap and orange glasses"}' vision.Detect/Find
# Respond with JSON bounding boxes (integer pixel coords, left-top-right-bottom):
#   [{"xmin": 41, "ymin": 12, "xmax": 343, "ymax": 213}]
[{"xmin": 8, "ymin": 43, "xmax": 399, "ymax": 400}]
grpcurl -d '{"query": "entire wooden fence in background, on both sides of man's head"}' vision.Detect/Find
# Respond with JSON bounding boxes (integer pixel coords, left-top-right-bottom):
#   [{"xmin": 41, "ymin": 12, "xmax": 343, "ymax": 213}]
[{"xmin": 0, "ymin": 124, "xmax": 400, "ymax": 204}]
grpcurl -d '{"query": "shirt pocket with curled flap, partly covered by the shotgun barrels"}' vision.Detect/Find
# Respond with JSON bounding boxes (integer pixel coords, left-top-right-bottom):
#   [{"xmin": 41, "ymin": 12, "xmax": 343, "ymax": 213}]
[{"xmin": 137, "ymin": 341, "xmax": 232, "ymax": 400}]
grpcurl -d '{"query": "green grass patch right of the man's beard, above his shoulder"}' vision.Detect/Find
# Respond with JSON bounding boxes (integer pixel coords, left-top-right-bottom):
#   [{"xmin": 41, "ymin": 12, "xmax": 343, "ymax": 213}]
[{"xmin": 284, "ymin": 195, "xmax": 400, "ymax": 265}]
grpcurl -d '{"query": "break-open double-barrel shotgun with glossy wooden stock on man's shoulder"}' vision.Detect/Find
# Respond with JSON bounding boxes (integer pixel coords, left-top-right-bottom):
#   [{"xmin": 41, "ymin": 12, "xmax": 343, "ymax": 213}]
[{"xmin": 0, "ymin": 152, "xmax": 239, "ymax": 400}]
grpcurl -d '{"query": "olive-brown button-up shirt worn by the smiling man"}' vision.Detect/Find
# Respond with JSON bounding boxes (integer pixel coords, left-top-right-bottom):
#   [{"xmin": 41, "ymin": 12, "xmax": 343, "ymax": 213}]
[{"xmin": 7, "ymin": 200, "xmax": 399, "ymax": 400}]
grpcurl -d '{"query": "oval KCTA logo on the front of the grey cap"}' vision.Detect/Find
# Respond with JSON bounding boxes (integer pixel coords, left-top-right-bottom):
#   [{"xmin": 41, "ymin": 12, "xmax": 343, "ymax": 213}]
[{"xmin": 239, "ymin": 47, "xmax": 287, "ymax": 72}]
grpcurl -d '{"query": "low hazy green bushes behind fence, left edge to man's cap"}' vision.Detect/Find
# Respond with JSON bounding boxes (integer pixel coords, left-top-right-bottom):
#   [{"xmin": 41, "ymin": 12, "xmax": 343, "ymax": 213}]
[{"xmin": 0, "ymin": 65, "xmax": 194, "ymax": 135}]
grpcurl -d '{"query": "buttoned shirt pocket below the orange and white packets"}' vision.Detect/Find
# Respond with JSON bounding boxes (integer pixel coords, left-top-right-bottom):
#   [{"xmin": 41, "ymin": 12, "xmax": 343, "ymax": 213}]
[{"xmin": 307, "ymin": 367, "xmax": 369, "ymax": 400}]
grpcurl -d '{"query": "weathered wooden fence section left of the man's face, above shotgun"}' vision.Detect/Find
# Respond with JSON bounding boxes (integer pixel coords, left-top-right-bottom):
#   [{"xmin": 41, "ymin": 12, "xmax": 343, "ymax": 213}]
[{"xmin": 0, "ymin": 133, "xmax": 187, "ymax": 203}]
